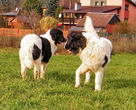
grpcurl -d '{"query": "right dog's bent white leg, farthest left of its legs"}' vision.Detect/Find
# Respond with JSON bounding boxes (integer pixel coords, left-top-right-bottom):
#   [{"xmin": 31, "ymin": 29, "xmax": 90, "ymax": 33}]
[{"xmin": 75, "ymin": 64, "xmax": 88, "ymax": 87}]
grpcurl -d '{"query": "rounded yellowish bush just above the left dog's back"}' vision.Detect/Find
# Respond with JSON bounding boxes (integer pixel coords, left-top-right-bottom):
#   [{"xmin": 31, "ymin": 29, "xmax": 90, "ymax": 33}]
[{"xmin": 40, "ymin": 16, "xmax": 59, "ymax": 32}]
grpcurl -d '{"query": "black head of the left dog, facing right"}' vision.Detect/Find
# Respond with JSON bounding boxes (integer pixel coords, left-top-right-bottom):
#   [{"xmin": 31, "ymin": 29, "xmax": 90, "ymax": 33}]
[{"xmin": 50, "ymin": 28, "xmax": 66, "ymax": 45}]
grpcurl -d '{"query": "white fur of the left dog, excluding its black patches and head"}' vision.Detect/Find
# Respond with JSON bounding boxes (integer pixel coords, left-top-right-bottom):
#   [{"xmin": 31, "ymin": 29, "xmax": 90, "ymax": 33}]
[{"xmin": 19, "ymin": 30, "xmax": 57, "ymax": 79}]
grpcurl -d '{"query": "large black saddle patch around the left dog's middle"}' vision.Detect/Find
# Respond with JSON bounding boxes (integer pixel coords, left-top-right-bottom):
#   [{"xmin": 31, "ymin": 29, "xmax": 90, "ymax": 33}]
[{"xmin": 40, "ymin": 37, "xmax": 52, "ymax": 63}]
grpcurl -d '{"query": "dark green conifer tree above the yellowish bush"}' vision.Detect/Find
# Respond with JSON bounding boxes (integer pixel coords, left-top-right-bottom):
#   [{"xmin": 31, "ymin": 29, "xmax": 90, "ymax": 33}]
[{"xmin": 45, "ymin": 0, "xmax": 59, "ymax": 17}]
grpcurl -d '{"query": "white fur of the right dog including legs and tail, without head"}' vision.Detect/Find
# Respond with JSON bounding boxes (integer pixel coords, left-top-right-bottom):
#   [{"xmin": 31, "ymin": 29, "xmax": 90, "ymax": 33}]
[{"xmin": 75, "ymin": 16, "xmax": 112, "ymax": 90}]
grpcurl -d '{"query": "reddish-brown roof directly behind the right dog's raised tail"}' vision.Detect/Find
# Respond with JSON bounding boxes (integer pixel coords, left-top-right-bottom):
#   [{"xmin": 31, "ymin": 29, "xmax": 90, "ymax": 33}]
[{"xmin": 77, "ymin": 12, "xmax": 120, "ymax": 28}]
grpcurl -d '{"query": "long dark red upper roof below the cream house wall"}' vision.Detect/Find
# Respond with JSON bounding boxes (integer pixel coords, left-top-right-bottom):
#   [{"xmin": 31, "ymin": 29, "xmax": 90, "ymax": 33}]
[{"xmin": 62, "ymin": 6, "xmax": 121, "ymax": 13}]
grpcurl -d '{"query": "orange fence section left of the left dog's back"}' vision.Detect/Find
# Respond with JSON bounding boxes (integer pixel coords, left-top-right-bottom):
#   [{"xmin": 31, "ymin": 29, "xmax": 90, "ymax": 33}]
[{"xmin": 0, "ymin": 28, "xmax": 34, "ymax": 37}]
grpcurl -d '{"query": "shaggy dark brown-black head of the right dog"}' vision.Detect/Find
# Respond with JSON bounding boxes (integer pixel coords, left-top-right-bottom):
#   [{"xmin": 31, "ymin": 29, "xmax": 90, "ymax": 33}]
[{"xmin": 65, "ymin": 32, "xmax": 86, "ymax": 54}]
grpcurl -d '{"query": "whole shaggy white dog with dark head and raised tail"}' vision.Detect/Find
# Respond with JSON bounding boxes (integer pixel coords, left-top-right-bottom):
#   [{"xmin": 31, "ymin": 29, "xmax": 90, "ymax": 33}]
[{"xmin": 65, "ymin": 16, "xmax": 112, "ymax": 90}]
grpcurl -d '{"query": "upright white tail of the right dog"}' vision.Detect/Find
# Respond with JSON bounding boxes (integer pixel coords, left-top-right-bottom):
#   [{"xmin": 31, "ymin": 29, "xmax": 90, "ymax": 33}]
[{"xmin": 84, "ymin": 16, "xmax": 97, "ymax": 35}]
